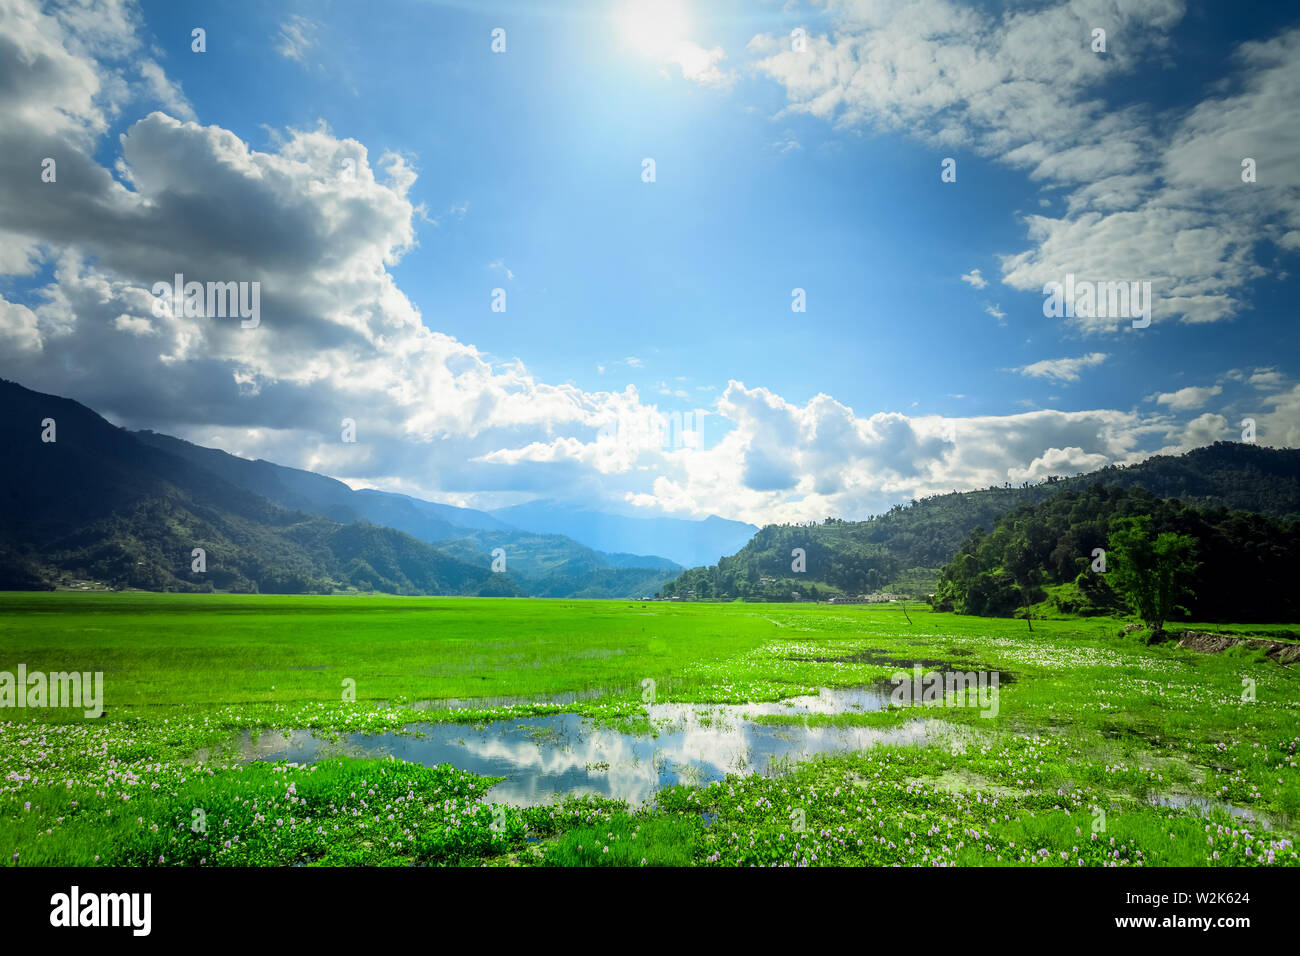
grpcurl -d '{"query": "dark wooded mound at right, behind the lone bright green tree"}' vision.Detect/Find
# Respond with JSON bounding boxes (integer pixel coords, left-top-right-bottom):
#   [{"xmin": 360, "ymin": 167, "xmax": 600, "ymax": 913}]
[{"xmin": 933, "ymin": 483, "xmax": 1300, "ymax": 622}]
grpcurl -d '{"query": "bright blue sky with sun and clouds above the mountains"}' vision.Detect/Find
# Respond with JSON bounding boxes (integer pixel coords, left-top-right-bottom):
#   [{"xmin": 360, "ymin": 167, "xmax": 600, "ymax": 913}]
[{"xmin": 0, "ymin": 0, "xmax": 1300, "ymax": 523}]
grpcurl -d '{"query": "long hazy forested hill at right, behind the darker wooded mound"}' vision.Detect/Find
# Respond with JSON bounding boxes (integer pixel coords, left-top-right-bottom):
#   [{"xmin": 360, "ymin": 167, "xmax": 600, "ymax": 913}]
[{"xmin": 663, "ymin": 442, "xmax": 1300, "ymax": 601}]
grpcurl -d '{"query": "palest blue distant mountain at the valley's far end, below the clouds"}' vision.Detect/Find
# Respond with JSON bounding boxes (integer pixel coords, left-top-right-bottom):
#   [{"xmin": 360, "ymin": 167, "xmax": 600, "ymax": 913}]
[{"xmin": 491, "ymin": 501, "xmax": 758, "ymax": 567}]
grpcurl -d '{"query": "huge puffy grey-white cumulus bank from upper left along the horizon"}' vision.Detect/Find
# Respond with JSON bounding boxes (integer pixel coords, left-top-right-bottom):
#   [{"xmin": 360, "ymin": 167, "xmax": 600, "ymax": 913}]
[{"xmin": 0, "ymin": 0, "xmax": 1279, "ymax": 523}]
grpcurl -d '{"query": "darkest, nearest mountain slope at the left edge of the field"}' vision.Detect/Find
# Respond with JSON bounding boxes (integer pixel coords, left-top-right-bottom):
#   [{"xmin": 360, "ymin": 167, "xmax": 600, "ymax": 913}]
[{"xmin": 0, "ymin": 381, "xmax": 519, "ymax": 594}]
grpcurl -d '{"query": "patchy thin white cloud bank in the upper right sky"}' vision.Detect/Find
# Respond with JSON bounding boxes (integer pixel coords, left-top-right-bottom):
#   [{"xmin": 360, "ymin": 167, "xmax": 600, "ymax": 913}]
[{"xmin": 750, "ymin": 0, "xmax": 1300, "ymax": 333}]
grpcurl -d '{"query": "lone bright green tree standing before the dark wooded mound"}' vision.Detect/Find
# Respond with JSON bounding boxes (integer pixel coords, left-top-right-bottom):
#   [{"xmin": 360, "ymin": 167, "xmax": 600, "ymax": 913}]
[{"xmin": 1108, "ymin": 515, "xmax": 1199, "ymax": 635}]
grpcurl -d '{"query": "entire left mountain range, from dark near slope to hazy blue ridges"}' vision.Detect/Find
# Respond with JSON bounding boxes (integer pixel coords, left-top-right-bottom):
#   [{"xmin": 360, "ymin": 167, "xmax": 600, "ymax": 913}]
[{"xmin": 0, "ymin": 382, "xmax": 681, "ymax": 597}]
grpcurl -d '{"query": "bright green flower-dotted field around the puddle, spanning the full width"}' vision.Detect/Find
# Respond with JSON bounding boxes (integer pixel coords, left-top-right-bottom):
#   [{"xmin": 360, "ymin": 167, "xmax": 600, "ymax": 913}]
[{"xmin": 0, "ymin": 593, "xmax": 1300, "ymax": 866}]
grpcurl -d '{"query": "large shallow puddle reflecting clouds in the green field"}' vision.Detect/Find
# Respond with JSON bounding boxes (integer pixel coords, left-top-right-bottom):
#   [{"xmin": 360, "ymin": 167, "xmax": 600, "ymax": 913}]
[{"xmin": 242, "ymin": 687, "xmax": 967, "ymax": 806}]
